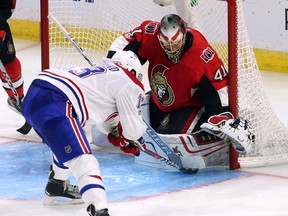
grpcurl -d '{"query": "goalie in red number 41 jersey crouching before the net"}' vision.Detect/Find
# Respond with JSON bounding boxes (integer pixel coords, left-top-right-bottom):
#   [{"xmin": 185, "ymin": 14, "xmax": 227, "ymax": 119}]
[{"xmin": 107, "ymin": 14, "xmax": 255, "ymax": 153}]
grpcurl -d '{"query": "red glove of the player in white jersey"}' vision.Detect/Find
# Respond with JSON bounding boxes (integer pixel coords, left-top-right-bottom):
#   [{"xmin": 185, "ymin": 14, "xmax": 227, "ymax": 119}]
[{"xmin": 107, "ymin": 123, "xmax": 146, "ymax": 156}]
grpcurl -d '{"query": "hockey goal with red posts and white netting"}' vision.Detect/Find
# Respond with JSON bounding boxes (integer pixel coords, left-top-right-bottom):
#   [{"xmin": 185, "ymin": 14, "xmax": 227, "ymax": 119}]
[{"xmin": 41, "ymin": 0, "xmax": 288, "ymax": 169}]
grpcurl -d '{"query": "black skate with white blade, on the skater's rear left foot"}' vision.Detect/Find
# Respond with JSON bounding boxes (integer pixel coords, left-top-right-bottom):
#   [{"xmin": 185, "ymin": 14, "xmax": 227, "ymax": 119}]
[{"xmin": 44, "ymin": 166, "xmax": 84, "ymax": 205}]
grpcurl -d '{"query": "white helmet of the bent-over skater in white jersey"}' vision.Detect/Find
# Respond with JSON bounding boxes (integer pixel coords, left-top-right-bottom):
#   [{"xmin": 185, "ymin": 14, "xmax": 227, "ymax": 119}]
[{"xmin": 104, "ymin": 50, "xmax": 143, "ymax": 82}]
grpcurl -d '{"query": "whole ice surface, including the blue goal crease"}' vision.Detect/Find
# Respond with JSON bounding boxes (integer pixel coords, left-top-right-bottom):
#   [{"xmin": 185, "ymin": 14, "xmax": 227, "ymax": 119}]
[{"xmin": 0, "ymin": 40, "xmax": 288, "ymax": 216}]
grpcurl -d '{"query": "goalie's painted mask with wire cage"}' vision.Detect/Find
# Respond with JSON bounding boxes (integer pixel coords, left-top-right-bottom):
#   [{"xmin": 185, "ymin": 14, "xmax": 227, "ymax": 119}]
[{"xmin": 158, "ymin": 14, "xmax": 187, "ymax": 63}]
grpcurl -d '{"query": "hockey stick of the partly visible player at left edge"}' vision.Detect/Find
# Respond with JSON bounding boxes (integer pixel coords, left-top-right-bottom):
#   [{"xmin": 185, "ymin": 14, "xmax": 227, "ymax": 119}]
[{"xmin": 0, "ymin": 59, "xmax": 32, "ymax": 135}]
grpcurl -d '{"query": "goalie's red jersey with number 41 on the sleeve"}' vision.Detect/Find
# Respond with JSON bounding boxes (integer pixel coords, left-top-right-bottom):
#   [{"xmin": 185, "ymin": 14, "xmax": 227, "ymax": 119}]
[{"xmin": 108, "ymin": 16, "xmax": 228, "ymax": 132}]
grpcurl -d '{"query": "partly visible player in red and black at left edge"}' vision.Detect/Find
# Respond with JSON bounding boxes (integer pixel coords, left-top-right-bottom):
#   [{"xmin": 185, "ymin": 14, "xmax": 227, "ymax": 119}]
[{"xmin": 0, "ymin": 0, "xmax": 24, "ymax": 113}]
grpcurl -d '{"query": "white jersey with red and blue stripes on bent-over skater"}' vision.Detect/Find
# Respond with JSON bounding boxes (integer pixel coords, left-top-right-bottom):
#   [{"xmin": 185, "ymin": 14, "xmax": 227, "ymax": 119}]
[{"xmin": 36, "ymin": 64, "xmax": 146, "ymax": 140}]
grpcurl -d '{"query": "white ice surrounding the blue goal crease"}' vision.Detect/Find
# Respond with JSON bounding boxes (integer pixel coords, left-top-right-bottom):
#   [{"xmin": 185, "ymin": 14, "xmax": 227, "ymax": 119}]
[{"xmin": 0, "ymin": 40, "xmax": 288, "ymax": 216}]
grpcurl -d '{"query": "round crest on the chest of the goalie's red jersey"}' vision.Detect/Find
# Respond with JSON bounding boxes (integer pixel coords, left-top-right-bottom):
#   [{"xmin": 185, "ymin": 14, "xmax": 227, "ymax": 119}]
[{"xmin": 151, "ymin": 65, "xmax": 175, "ymax": 106}]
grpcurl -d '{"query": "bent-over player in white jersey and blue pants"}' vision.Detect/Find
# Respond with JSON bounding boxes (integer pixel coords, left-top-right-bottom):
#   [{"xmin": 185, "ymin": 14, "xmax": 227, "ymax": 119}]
[{"xmin": 22, "ymin": 51, "xmax": 146, "ymax": 216}]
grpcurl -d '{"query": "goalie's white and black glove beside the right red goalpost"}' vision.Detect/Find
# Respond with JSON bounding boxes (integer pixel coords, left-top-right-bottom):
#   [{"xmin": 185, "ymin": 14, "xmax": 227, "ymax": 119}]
[{"xmin": 201, "ymin": 112, "xmax": 255, "ymax": 154}]
